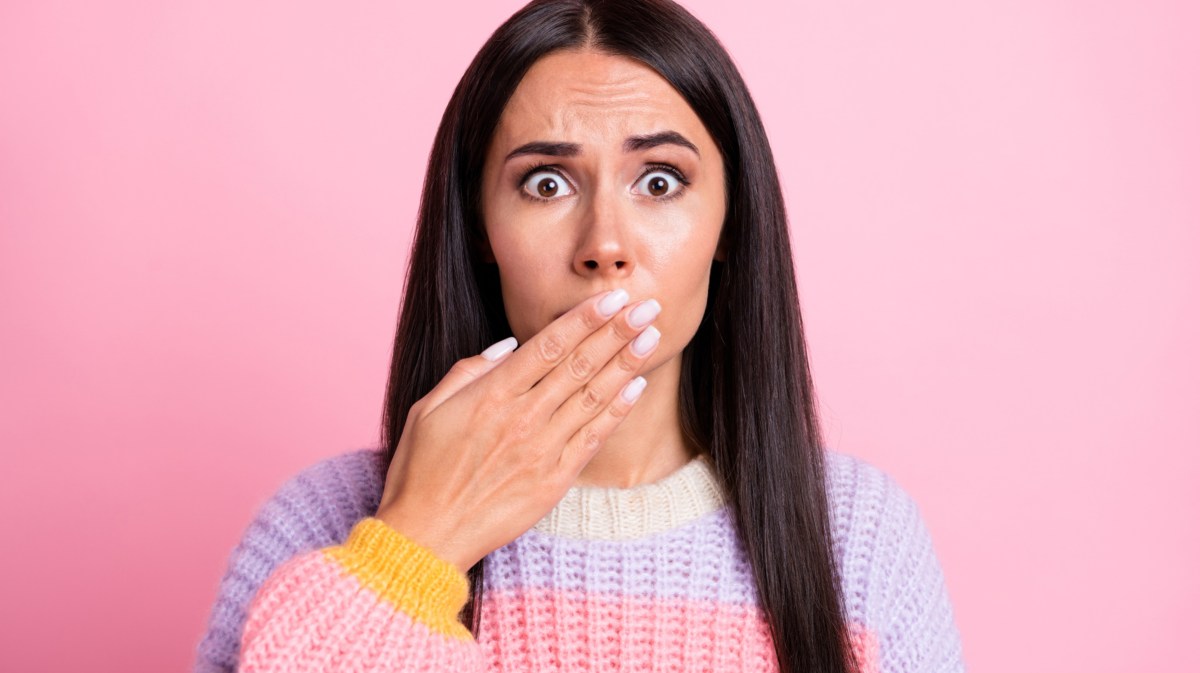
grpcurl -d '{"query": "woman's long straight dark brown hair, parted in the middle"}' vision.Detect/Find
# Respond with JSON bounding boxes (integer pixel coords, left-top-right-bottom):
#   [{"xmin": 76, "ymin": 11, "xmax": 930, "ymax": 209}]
[{"xmin": 382, "ymin": 0, "xmax": 858, "ymax": 673}]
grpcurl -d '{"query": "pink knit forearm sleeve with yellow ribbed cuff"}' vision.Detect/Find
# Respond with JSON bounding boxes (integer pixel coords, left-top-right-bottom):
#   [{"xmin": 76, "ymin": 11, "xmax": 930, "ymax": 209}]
[{"xmin": 239, "ymin": 517, "xmax": 486, "ymax": 673}]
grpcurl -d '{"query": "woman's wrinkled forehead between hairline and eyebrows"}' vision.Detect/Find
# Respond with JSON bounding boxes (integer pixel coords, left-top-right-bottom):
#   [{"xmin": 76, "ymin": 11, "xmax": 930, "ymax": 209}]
[{"xmin": 496, "ymin": 50, "xmax": 712, "ymax": 148}]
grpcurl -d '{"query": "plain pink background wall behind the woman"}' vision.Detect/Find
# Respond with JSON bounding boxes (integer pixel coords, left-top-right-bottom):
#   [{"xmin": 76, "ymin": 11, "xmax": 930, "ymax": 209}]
[{"xmin": 0, "ymin": 0, "xmax": 1200, "ymax": 673}]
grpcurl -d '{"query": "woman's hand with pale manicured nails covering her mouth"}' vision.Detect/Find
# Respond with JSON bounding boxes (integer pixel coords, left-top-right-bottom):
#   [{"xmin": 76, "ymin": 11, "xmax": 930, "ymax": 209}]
[{"xmin": 376, "ymin": 290, "xmax": 659, "ymax": 572}]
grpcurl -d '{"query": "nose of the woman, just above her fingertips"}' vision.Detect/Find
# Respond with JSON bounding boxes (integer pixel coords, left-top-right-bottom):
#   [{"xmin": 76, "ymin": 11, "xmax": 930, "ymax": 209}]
[{"xmin": 574, "ymin": 189, "xmax": 636, "ymax": 278}]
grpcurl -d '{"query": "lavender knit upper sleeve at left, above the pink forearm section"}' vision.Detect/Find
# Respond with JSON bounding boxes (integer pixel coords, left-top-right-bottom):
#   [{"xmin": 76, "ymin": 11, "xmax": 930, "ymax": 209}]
[{"xmin": 193, "ymin": 450, "xmax": 383, "ymax": 673}]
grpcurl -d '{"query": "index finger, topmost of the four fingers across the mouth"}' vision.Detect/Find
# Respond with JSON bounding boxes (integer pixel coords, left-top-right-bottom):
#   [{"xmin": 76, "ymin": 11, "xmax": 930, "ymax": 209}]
[{"xmin": 500, "ymin": 289, "xmax": 629, "ymax": 395}]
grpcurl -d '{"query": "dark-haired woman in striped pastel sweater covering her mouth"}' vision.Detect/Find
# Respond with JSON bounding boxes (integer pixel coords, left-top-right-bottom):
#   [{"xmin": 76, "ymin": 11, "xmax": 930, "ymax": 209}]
[{"xmin": 198, "ymin": 0, "xmax": 961, "ymax": 672}]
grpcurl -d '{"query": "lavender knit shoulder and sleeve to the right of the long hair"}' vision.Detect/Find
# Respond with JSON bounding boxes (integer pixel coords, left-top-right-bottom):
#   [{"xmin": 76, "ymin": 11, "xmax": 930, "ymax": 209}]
[{"xmin": 828, "ymin": 453, "xmax": 966, "ymax": 673}]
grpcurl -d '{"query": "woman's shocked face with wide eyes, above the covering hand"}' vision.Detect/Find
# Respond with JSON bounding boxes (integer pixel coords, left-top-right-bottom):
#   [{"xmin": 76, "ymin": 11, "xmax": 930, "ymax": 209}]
[{"xmin": 482, "ymin": 50, "xmax": 725, "ymax": 369}]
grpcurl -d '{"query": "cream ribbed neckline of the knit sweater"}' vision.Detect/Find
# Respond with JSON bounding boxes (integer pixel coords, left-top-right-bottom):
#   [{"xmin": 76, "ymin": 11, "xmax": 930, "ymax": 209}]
[{"xmin": 534, "ymin": 455, "xmax": 725, "ymax": 540}]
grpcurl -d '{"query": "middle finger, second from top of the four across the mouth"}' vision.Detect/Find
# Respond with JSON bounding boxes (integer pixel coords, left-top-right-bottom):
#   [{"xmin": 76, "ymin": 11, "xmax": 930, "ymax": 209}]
[{"xmin": 529, "ymin": 299, "xmax": 661, "ymax": 415}]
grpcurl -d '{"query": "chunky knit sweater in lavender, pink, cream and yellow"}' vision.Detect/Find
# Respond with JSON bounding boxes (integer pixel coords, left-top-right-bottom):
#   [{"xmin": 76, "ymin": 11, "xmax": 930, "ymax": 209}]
[{"xmin": 194, "ymin": 451, "xmax": 964, "ymax": 673}]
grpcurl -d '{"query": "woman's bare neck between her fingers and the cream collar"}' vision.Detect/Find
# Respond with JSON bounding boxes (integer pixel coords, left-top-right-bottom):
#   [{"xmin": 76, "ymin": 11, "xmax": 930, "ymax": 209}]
[{"xmin": 575, "ymin": 354, "xmax": 700, "ymax": 488}]
